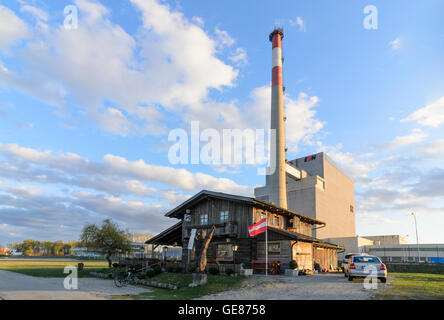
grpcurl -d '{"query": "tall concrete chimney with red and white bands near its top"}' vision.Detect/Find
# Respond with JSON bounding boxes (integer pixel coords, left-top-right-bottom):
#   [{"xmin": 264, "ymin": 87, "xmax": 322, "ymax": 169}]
[{"xmin": 269, "ymin": 28, "xmax": 287, "ymax": 209}]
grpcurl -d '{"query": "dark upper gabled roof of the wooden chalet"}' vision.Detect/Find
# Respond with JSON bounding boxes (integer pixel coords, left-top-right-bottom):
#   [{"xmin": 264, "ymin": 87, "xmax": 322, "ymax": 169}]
[{"xmin": 165, "ymin": 190, "xmax": 325, "ymax": 225}]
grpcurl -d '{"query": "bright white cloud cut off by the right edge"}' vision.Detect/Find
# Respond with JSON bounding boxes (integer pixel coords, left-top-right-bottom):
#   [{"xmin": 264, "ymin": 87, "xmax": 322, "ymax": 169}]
[{"xmin": 401, "ymin": 96, "xmax": 444, "ymax": 128}]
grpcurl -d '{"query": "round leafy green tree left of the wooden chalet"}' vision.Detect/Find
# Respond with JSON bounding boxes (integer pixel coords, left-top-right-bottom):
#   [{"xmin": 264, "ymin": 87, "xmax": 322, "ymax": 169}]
[{"xmin": 80, "ymin": 219, "xmax": 131, "ymax": 268}]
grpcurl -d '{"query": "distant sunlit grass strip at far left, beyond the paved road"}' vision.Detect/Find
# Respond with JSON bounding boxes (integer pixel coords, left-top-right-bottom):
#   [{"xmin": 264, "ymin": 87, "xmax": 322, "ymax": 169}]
[{"xmin": 0, "ymin": 259, "xmax": 108, "ymax": 278}]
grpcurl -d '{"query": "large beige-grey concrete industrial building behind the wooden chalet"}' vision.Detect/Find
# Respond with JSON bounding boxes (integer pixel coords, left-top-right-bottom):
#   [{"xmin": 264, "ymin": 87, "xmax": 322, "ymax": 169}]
[{"xmin": 254, "ymin": 152, "xmax": 356, "ymax": 239}]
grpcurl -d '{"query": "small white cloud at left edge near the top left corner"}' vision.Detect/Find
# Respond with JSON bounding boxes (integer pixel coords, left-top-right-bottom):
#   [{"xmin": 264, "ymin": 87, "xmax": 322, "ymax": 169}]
[{"xmin": 0, "ymin": 5, "xmax": 28, "ymax": 49}]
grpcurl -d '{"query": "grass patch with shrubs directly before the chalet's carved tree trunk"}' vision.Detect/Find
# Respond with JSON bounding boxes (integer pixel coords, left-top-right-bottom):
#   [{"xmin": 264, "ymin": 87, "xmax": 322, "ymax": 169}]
[{"xmin": 118, "ymin": 272, "xmax": 245, "ymax": 300}]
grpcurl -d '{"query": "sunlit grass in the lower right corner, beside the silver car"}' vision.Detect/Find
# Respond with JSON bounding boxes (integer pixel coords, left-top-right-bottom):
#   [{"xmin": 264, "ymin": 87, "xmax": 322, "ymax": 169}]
[{"xmin": 374, "ymin": 273, "xmax": 444, "ymax": 300}]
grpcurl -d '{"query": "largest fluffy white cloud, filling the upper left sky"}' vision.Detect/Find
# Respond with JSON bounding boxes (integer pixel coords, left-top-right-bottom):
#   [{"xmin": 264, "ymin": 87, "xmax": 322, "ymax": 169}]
[{"xmin": 0, "ymin": 0, "xmax": 238, "ymax": 135}]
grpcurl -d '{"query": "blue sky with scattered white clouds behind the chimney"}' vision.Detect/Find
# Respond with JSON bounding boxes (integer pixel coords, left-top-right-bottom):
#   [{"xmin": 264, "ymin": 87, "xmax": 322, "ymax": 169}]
[{"xmin": 0, "ymin": 0, "xmax": 444, "ymax": 245}]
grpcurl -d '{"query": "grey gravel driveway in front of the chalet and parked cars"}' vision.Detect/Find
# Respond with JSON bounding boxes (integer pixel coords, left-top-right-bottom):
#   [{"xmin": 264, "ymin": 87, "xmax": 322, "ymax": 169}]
[{"xmin": 199, "ymin": 273, "xmax": 385, "ymax": 300}]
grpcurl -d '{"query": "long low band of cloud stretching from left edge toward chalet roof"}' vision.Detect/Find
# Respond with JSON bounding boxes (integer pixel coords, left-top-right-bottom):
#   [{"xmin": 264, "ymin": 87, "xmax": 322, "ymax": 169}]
[{"xmin": 0, "ymin": 144, "xmax": 252, "ymax": 196}]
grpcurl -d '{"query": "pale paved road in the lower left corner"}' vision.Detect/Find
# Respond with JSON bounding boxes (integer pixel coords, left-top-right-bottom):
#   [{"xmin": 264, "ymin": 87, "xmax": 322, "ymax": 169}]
[{"xmin": 0, "ymin": 270, "xmax": 150, "ymax": 300}]
